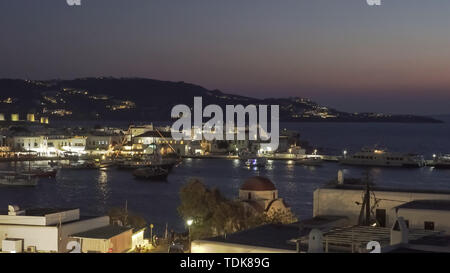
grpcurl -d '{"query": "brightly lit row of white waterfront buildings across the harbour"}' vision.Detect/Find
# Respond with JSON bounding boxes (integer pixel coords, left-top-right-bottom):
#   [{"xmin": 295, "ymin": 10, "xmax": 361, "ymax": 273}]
[{"xmin": 0, "ymin": 125, "xmax": 299, "ymax": 157}]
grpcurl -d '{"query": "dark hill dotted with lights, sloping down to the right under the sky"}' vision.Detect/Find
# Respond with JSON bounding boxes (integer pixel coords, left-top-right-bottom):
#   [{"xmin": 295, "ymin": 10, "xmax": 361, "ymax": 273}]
[{"xmin": 0, "ymin": 77, "xmax": 441, "ymax": 123}]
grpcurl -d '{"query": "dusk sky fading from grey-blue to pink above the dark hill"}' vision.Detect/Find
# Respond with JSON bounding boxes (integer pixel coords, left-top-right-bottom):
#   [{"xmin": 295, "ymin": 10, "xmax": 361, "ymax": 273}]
[{"xmin": 0, "ymin": 0, "xmax": 450, "ymax": 114}]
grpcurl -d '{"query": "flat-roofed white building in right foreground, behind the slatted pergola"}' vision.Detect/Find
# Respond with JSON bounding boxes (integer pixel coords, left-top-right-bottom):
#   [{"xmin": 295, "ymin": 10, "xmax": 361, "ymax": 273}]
[{"xmin": 313, "ymin": 183, "xmax": 450, "ymax": 231}]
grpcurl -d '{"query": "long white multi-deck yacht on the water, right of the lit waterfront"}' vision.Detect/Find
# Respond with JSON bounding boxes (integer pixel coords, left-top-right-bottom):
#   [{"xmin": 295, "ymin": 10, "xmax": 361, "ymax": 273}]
[{"xmin": 340, "ymin": 148, "xmax": 425, "ymax": 168}]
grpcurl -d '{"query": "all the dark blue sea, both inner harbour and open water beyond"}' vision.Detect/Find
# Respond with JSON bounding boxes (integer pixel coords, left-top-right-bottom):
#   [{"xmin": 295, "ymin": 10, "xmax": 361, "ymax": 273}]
[{"xmin": 0, "ymin": 119, "xmax": 450, "ymax": 232}]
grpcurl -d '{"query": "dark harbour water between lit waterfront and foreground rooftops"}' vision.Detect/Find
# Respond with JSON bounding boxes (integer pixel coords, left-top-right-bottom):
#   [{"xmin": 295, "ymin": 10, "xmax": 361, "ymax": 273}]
[{"xmin": 0, "ymin": 159, "xmax": 450, "ymax": 231}]
